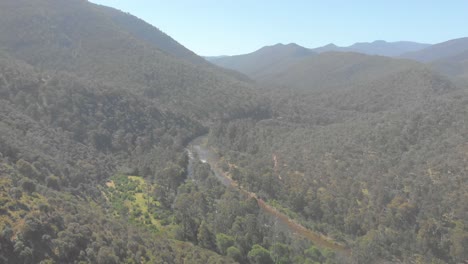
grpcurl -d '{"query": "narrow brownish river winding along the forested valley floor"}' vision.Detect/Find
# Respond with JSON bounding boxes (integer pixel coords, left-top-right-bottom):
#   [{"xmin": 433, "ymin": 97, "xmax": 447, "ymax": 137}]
[{"xmin": 187, "ymin": 136, "xmax": 350, "ymax": 255}]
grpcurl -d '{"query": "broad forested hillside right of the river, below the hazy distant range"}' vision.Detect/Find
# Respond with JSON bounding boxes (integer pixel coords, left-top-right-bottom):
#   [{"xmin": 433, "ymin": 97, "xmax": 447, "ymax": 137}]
[{"xmin": 207, "ymin": 53, "xmax": 468, "ymax": 263}]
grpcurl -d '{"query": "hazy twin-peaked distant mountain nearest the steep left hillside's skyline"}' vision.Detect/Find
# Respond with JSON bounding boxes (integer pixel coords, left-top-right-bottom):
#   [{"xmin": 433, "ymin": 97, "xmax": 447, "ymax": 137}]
[{"xmin": 210, "ymin": 43, "xmax": 314, "ymax": 79}]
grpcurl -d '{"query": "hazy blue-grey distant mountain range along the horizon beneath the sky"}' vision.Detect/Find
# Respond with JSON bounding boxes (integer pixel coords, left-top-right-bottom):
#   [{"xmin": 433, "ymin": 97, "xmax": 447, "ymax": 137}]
[{"xmin": 205, "ymin": 38, "xmax": 468, "ymax": 80}]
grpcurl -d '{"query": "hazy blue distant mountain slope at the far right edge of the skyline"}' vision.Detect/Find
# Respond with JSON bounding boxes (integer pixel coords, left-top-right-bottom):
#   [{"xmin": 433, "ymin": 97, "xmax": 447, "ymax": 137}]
[{"xmin": 401, "ymin": 38, "xmax": 468, "ymax": 62}]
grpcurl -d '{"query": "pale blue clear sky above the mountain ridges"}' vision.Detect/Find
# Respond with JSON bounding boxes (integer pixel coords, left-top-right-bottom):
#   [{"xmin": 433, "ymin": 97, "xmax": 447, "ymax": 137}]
[{"xmin": 91, "ymin": 0, "xmax": 468, "ymax": 56}]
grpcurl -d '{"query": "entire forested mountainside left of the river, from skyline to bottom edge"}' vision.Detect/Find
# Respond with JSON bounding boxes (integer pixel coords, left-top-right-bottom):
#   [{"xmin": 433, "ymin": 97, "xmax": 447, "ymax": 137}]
[{"xmin": 0, "ymin": 0, "xmax": 337, "ymax": 263}]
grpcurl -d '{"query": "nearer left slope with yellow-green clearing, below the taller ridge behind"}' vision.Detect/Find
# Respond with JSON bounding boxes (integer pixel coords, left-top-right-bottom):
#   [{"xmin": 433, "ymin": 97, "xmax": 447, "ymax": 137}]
[{"xmin": 0, "ymin": 53, "xmax": 334, "ymax": 264}]
